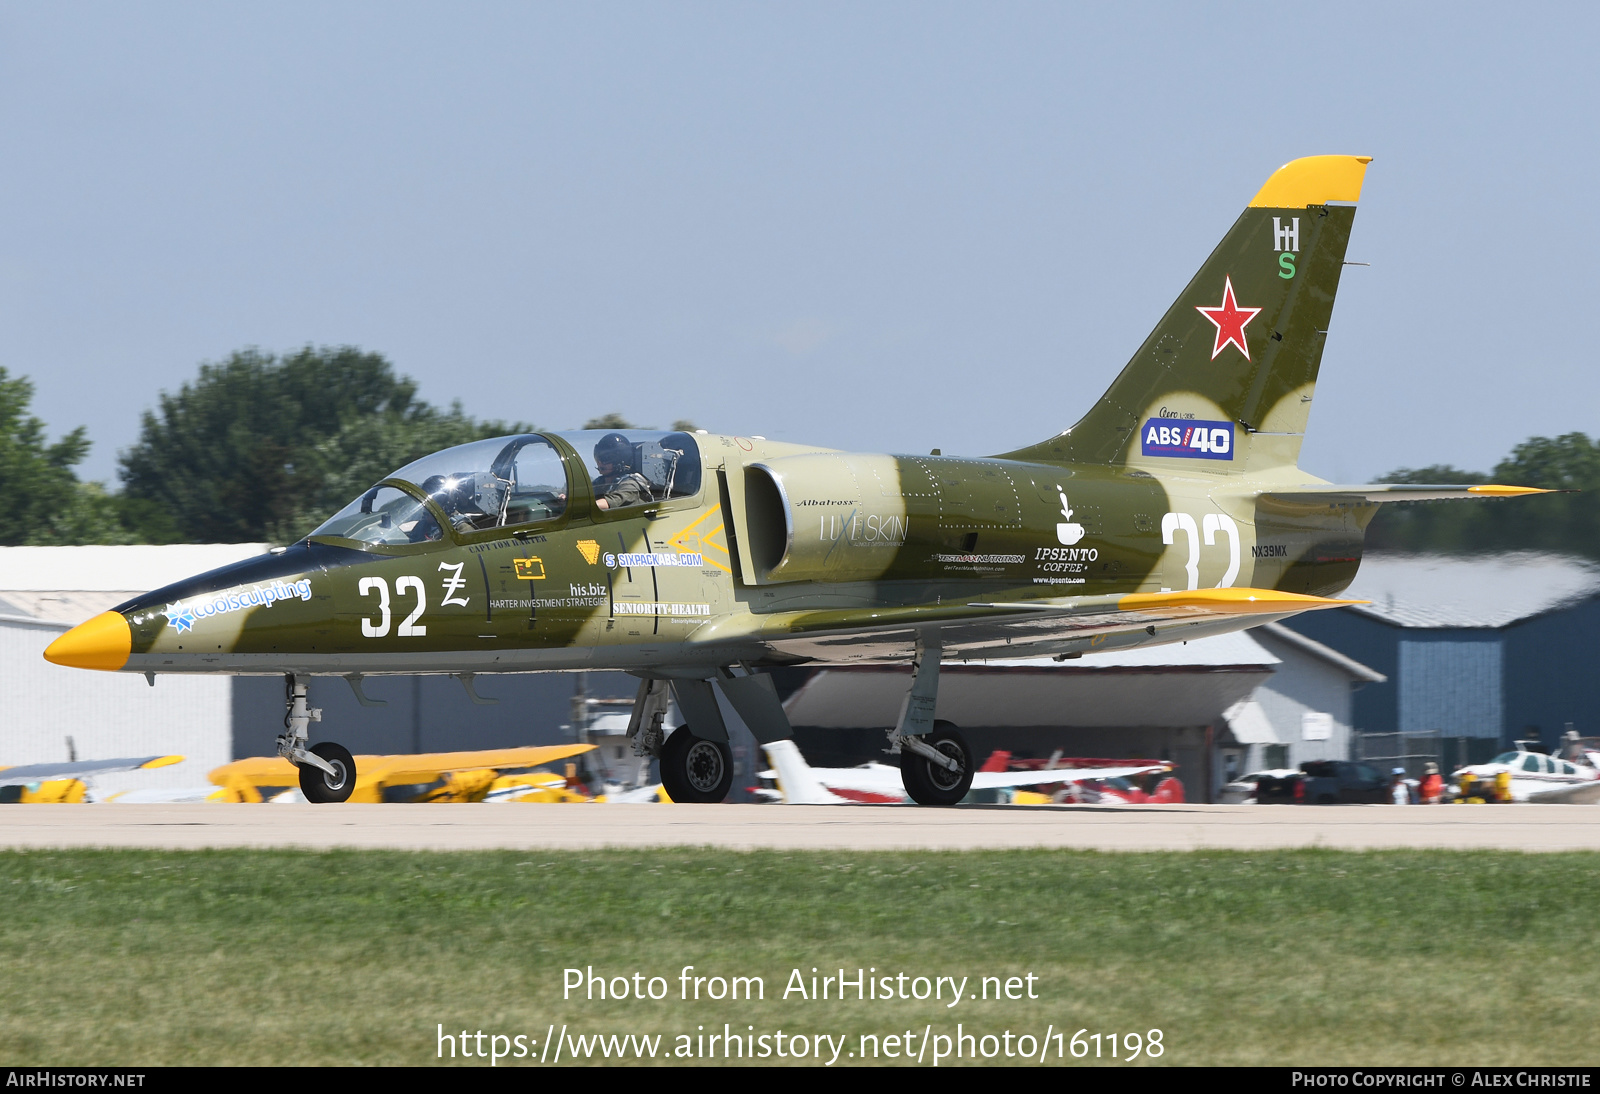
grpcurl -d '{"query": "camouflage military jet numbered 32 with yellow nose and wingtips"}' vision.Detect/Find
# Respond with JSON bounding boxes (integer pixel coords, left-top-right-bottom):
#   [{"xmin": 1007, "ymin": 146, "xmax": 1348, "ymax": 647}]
[{"xmin": 45, "ymin": 155, "xmax": 1539, "ymax": 805}]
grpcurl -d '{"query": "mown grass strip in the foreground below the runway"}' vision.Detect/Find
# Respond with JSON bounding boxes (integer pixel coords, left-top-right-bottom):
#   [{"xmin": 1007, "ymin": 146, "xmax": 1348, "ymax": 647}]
[{"xmin": 0, "ymin": 849, "xmax": 1600, "ymax": 1065}]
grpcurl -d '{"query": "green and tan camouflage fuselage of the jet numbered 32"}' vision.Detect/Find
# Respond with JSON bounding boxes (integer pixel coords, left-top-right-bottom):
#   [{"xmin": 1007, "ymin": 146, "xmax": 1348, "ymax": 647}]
[{"xmin": 109, "ymin": 435, "xmax": 1371, "ymax": 673}]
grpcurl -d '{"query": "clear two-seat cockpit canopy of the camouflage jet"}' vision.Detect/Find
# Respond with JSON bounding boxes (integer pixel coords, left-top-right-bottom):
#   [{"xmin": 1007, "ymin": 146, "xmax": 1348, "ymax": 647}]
[{"xmin": 312, "ymin": 429, "xmax": 701, "ymax": 547}]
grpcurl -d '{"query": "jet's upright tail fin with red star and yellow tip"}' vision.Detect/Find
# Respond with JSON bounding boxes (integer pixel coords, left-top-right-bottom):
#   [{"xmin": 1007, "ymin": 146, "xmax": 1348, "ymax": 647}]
[{"xmin": 1003, "ymin": 155, "xmax": 1371, "ymax": 473}]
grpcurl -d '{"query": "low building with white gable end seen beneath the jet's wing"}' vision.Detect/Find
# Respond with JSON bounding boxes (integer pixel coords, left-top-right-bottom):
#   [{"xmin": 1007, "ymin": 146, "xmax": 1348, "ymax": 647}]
[{"xmin": 784, "ymin": 624, "xmax": 1384, "ymax": 801}]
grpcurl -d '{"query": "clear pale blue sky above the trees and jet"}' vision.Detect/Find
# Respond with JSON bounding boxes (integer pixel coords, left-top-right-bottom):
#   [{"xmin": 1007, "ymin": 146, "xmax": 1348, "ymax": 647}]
[{"xmin": 0, "ymin": 3, "xmax": 1600, "ymax": 481}]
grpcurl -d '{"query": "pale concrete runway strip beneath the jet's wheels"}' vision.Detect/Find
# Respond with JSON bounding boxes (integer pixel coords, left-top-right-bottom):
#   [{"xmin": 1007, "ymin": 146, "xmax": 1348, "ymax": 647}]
[{"xmin": 0, "ymin": 805, "xmax": 1600, "ymax": 851}]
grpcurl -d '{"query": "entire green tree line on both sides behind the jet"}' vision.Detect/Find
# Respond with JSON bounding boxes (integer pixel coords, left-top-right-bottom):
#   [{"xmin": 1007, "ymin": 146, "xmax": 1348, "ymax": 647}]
[{"xmin": 0, "ymin": 345, "xmax": 1580, "ymax": 558}]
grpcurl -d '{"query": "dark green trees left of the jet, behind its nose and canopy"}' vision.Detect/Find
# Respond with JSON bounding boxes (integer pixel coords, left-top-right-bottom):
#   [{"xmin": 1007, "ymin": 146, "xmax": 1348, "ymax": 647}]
[{"xmin": 0, "ymin": 345, "xmax": 693, "ymax": 545}]
